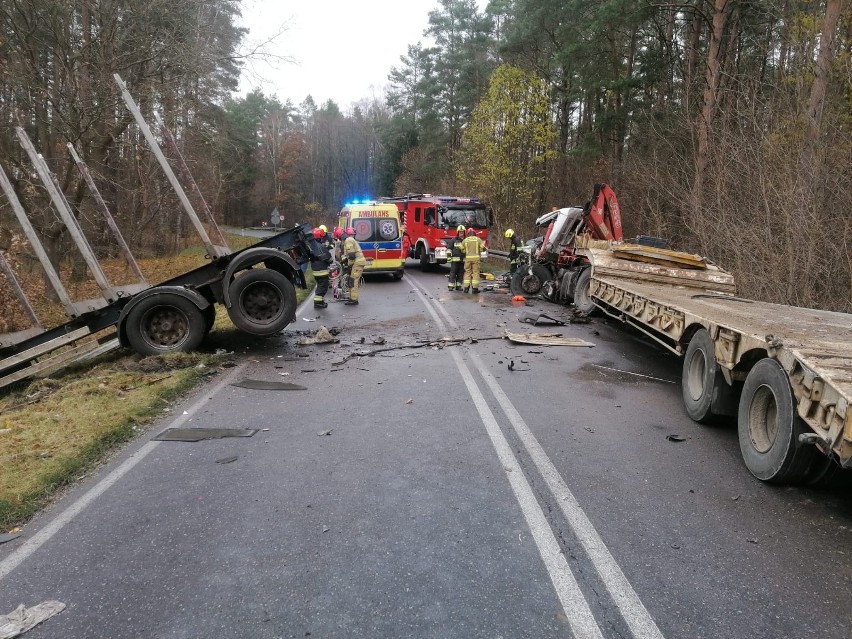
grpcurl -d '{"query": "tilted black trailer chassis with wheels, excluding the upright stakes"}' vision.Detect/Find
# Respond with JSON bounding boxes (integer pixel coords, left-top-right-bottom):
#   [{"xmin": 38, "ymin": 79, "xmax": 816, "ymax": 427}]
[{"xmin": 0, "ymin": 224, "xmax": 319, "ymax": 387}]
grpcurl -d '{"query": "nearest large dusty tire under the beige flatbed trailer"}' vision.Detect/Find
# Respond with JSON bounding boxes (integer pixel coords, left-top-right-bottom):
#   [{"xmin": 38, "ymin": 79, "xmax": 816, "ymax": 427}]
[{"xmin": 737, "ymin": 358, "xmax": 819, "ymax": 484}]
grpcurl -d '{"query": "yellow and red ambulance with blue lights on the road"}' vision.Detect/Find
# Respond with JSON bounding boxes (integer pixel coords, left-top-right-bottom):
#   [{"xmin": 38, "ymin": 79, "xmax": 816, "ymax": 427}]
[{"xmin": 338, "ymin": 201, "xmax": 405, "ymax": 280}]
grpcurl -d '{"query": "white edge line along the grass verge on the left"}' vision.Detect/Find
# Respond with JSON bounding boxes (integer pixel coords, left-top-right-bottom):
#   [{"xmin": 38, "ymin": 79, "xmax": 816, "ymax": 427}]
[{"xmin": 0, "ymin": 366, "xmax": 243, "ymax": 581}]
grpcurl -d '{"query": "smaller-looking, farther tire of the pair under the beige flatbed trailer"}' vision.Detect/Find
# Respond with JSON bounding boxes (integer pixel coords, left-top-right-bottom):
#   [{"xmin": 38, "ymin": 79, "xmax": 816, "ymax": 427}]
[{"xmin": 680, "ymin": 328, "xmax": 725, "ymax": 424}]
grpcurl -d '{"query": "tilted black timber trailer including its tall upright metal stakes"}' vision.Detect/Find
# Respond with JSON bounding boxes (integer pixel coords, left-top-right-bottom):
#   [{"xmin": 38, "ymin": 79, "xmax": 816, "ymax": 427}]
[{"xmin": 0, "ymin": 76, "xmax": 320, "ymax": 387}]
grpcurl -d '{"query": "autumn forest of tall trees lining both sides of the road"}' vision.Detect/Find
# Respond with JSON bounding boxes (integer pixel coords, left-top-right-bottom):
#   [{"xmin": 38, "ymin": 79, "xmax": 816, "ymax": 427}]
[{"xmin": 0, "ymin": 0, "xmax": 852, "ymax": 312}]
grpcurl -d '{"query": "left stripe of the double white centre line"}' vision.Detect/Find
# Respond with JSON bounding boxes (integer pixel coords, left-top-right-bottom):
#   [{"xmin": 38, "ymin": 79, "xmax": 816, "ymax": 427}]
[{"xmin": 414, "ymin": 283, "xmax": 603, "ymax": 639}]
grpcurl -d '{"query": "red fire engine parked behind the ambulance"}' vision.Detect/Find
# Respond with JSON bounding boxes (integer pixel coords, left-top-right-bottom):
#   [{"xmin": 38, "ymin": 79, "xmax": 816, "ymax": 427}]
[{"xmin": 381, "ymin": 193, "xmax": 491, "ymax": 269}]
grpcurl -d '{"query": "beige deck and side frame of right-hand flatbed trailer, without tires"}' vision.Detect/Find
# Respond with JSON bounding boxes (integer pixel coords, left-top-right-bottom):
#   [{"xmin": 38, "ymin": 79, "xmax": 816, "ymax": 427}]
[{"xmin": 587, "ymin": 249, "xmax": 852, "ymax": 467}]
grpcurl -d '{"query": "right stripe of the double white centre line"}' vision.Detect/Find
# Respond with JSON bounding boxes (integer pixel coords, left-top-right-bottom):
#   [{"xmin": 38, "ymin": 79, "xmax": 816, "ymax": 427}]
[{"xmin": 411, "ymin": 278, "xmax": 663, "ymax": 639}]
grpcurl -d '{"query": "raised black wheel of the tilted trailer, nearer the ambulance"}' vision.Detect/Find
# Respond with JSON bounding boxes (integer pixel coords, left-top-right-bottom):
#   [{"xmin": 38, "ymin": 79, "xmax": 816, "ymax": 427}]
[{"xmin": 228, "ymin": 268, "xmax": 297, "ymax": 335}]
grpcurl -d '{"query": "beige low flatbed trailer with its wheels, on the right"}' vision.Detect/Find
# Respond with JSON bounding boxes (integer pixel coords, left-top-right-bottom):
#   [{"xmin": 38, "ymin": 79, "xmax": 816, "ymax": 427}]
[{"xmin": 581, "ymin": 248, "xmax": 852, "ymax": 483}]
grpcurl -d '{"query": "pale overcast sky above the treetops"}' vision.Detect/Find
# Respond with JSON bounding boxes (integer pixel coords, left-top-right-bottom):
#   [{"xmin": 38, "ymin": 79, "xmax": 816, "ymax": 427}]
[{"xmin": 240, "ymin": 0, "xmax": 487, "ymax": 111}]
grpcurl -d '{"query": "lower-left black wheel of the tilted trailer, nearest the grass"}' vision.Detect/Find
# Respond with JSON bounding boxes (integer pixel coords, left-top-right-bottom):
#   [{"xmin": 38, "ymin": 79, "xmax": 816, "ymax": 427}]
[{"xmin": 124, "ymin": 293, "xmax": 207, "ymax": 355}]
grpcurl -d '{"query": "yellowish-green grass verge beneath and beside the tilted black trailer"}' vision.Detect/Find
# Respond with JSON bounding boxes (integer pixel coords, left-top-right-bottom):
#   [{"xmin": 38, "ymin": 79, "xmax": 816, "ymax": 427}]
[{"xmin": 0, "ymin": 236, "xmax": 313, "ymax": 531}]
